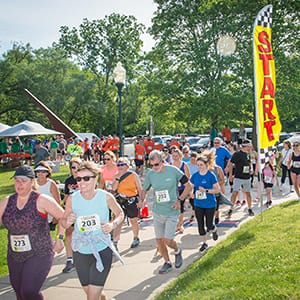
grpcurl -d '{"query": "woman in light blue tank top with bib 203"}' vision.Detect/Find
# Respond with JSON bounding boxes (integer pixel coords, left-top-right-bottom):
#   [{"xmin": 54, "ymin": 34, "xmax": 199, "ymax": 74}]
[{"xmin": 62, "ymin": 161, "xmax": 124, "ymax": 299}]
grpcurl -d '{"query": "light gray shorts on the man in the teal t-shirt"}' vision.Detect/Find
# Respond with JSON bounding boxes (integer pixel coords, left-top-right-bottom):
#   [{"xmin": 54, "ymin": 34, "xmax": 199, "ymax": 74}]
[{"xmin": 153, "ymin": 213, "xmax": 179, "ymax": 240}]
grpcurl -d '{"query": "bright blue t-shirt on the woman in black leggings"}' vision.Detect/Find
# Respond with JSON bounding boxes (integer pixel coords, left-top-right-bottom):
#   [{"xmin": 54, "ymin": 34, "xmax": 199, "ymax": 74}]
[{"xmin": 191, "ymin": 171, "xmax": 217, "ymax": 208}]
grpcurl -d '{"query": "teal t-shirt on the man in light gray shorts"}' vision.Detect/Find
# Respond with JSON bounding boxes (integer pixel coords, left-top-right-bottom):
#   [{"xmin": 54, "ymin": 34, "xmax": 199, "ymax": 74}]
[{"xmin": 143, "ymin": 166, "xmax": 184, "ymax": 216}]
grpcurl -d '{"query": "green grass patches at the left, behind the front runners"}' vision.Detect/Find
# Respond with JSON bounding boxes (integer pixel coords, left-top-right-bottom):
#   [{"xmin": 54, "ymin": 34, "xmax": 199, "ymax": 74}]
[{"xmin": 0, "ymin": 166, "xmax": 69, "ymax": 277}]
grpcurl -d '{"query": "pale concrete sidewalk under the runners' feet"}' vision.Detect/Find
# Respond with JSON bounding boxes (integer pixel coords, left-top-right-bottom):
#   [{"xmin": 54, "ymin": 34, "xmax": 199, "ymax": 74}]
[{"xmin": 0, "ymin": 185, "xmax": 296, "ymax": 300}]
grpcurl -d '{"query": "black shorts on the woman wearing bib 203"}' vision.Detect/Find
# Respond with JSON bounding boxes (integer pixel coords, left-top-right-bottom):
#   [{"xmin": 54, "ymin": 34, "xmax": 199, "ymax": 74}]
[{"xmin": 73, "ymin": 247, "xmax": 112, "ymax": 287}]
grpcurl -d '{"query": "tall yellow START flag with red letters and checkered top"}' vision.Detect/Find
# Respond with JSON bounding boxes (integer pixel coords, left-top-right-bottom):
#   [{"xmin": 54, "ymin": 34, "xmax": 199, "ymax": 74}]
[{"xmin": 253, "ymin": 5, "xmax": 281, "ymax": 148}]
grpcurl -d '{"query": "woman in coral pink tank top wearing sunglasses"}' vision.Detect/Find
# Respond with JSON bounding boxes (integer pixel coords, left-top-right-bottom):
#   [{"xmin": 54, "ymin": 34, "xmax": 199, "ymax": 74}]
[{"xmin": 100, "ymin": 150, "xmax": 118, "ymax": 192}]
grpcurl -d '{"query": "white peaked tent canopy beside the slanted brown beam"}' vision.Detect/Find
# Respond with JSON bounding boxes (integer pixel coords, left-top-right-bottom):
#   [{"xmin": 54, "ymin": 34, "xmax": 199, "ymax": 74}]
[{"xmin": 0, "ymin": 120, "xmax": 61, "ymax": 137}]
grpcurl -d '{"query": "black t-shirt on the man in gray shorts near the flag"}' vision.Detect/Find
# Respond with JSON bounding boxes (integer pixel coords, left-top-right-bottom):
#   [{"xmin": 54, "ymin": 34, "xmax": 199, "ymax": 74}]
[{"xmin": 230, "ymin": 150, "xmax": 251, "ymax": 179}]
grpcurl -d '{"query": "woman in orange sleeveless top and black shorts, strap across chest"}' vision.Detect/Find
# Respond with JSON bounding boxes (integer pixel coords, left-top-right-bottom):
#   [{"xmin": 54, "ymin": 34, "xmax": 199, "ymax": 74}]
[{"xmin": 113, "ymin": 157, "xmax": 142, "ymax": 248}]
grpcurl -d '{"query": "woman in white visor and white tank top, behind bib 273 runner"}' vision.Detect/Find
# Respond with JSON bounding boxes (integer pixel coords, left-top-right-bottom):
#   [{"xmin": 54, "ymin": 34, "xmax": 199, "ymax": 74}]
[{"xmin": 34, "ymin": 161, "xmax": 60, "ymax": 231}]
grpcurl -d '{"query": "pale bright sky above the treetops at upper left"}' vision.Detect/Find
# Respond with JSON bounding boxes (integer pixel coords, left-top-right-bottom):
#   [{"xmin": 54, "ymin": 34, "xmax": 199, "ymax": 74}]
[{"xmin": 0, "ymin": 0, "xmax": 156, "ymax": 53}]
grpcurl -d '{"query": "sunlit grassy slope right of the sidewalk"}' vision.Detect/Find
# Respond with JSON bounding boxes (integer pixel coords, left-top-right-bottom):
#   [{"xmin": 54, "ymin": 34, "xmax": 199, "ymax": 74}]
[{"xmin": 155, "ymin": 201, "xmax": 300, "ymax": 300}]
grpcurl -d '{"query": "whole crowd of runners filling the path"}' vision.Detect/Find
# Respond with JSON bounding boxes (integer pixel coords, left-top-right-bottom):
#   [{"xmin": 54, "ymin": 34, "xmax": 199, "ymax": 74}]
[{"xmin": 0, "ymin": 125, "xmax": 300, "ymax": 299}]
